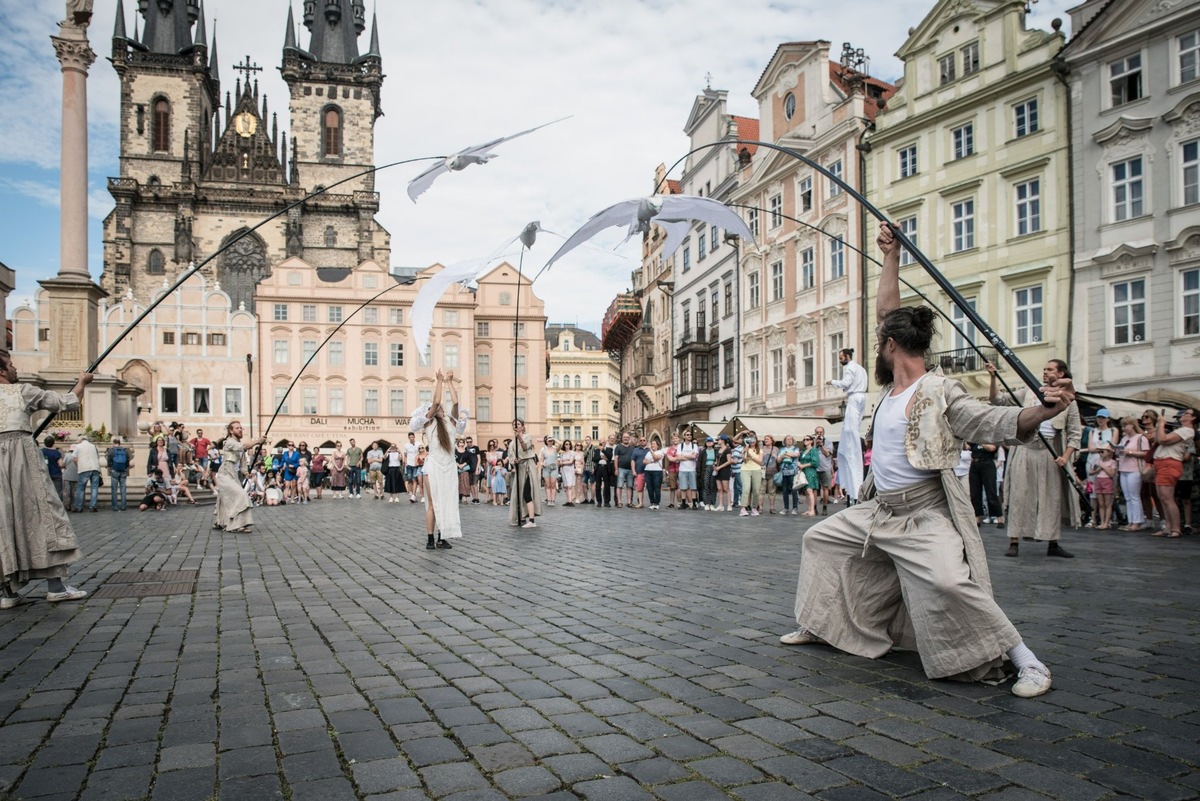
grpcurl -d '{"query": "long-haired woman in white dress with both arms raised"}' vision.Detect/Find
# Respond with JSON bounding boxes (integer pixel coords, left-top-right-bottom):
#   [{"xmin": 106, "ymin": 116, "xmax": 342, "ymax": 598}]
[{"xmin": 412, "ymin": 371, "xmax": 468, "ymax": 550}]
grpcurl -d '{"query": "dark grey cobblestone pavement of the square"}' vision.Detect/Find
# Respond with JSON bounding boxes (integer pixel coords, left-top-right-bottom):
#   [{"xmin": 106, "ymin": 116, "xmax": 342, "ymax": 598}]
[{"xmin": 0, "ymin": 499, "xmax": 1200, "ymax": 801}]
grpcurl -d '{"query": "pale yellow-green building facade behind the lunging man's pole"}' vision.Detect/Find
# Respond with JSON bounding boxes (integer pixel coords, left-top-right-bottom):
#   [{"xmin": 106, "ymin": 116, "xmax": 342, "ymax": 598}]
[{"xmin": 864, "ymin": 0, "xmax": 1072, "ymax": 393}]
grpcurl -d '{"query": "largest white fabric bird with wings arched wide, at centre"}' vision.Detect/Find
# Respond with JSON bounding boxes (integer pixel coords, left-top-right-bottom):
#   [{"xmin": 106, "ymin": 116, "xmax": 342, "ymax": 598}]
[{"xmin": 542, "ymin": 194, "xmax": 754, "ymax": 271}]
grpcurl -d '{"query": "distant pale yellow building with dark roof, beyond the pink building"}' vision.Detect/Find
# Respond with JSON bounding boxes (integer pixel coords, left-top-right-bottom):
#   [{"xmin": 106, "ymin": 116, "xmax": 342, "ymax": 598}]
[{"xmin": 546, "ymin": 324, "xmax": 620, "ymax": 442}]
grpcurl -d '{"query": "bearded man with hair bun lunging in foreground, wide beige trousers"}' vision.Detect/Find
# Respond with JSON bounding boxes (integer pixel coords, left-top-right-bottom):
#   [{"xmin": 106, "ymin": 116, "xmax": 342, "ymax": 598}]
[{"xmin": 780, "ymin": 224, "xmax": 1075, "ymax": 698}]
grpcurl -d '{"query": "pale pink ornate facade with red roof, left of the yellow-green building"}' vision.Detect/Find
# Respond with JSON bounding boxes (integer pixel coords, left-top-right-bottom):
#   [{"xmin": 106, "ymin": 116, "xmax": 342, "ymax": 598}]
[{"xmin": 733, "ymin": 41, "xmax": 894, "ymax": 417}]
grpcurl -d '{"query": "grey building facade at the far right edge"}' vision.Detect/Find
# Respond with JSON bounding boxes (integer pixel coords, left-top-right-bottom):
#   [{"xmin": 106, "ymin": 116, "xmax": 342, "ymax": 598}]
[{"xmin": 1062, "ymin": 0, "xmax": 1200, "ymax": 406}]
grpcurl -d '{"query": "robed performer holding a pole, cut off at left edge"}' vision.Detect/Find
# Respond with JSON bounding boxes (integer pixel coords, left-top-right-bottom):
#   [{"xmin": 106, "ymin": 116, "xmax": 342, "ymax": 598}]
[{"xmin": 0, "ymin": 350, "xmax": 91, "ymax": 609}]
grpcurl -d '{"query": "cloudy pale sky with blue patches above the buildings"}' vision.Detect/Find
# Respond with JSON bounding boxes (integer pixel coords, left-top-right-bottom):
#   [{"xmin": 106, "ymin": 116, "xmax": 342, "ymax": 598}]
[{"xmin": 0, "ymin": 0, "xmax": 1075, "ymax": 331}]
